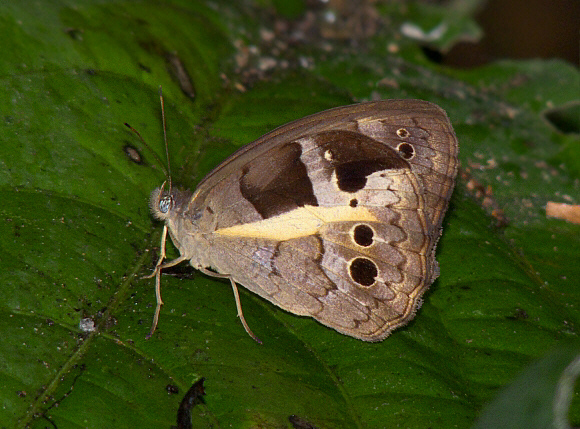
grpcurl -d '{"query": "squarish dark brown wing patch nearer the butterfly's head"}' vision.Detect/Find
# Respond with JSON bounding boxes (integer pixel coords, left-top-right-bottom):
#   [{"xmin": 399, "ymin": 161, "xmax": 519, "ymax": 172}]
[{"xmin": 240, "ymin": 143, "xmax": 318, "ymax": 219}]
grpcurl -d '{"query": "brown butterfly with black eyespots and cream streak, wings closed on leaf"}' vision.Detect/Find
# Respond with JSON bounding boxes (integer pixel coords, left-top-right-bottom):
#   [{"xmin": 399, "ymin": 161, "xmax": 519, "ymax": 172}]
[{"xmin": 149, "ymin": 100, "xmax": 459, "ymax": 341}]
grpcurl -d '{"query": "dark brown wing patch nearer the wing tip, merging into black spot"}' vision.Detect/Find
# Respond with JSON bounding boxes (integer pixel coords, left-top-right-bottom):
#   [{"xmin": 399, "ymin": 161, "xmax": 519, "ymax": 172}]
[{"xmin": 314, "ymin": 131, "xmax": 411, "ymax": 192}]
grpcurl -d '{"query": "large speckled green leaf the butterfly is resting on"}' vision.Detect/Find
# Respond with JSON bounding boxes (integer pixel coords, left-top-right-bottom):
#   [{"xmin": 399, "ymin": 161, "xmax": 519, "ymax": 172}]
[{"xmin": 0, "ymin": 0, "xmax": 580, "ymax": 429}]
